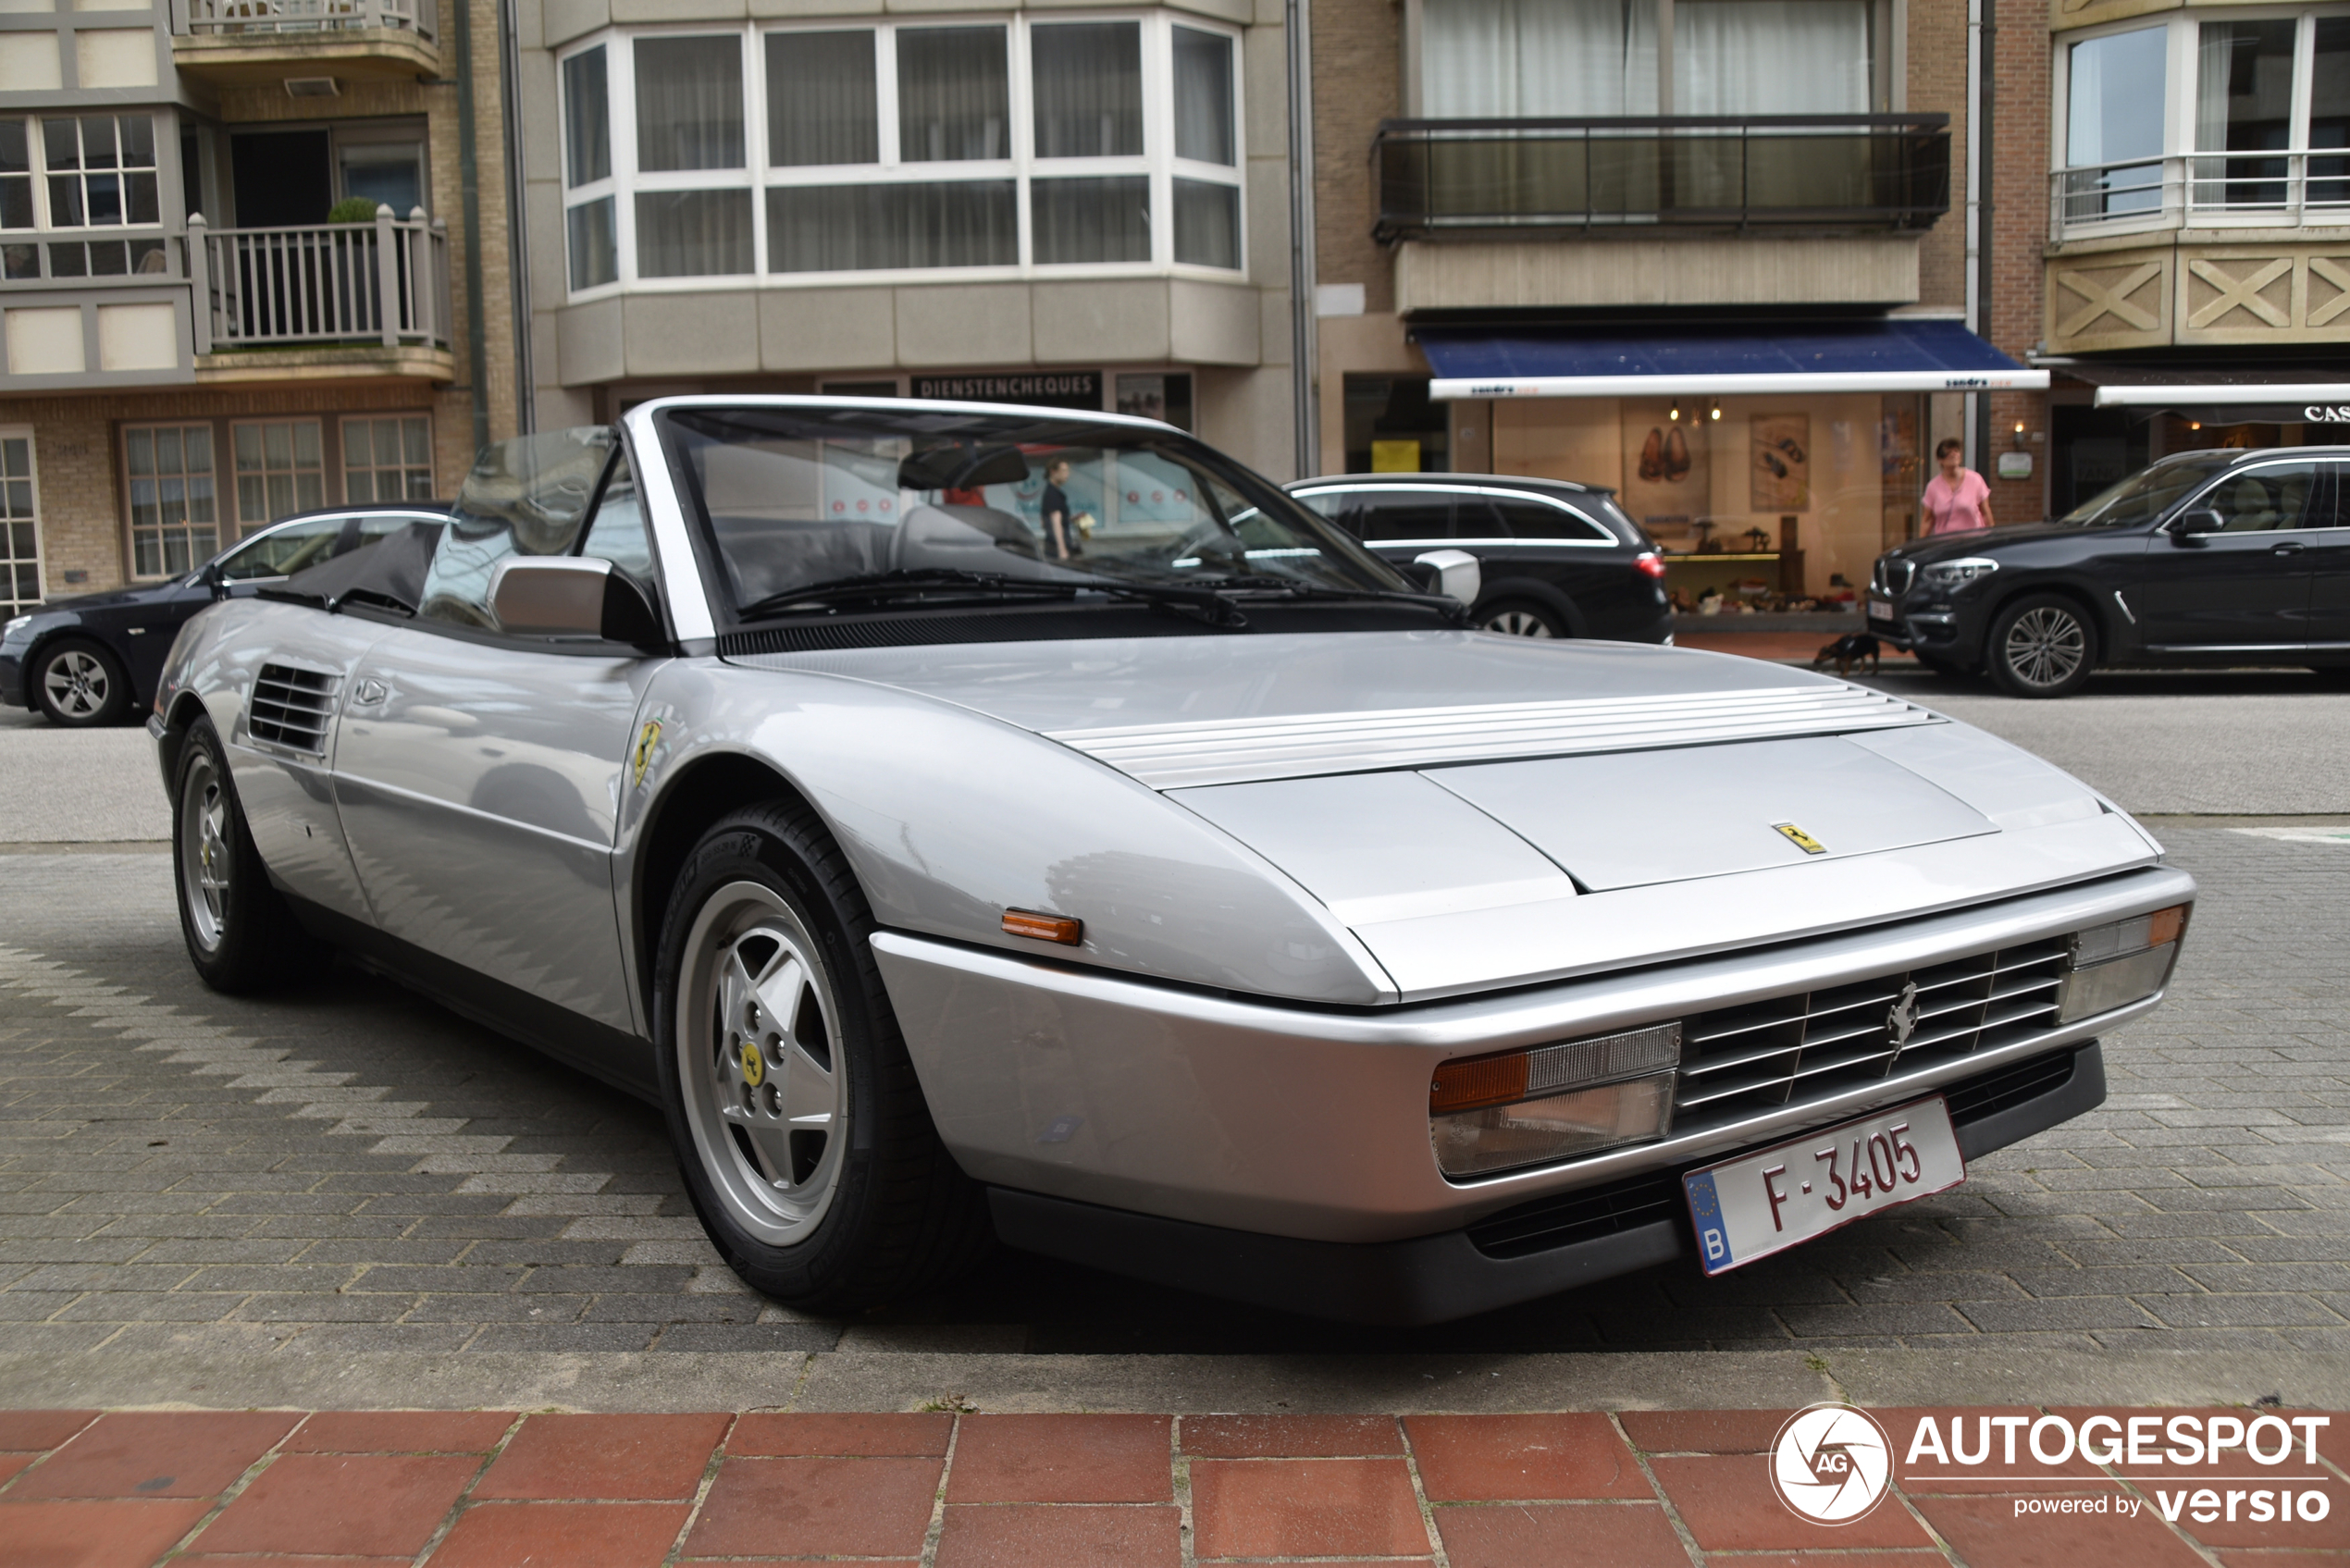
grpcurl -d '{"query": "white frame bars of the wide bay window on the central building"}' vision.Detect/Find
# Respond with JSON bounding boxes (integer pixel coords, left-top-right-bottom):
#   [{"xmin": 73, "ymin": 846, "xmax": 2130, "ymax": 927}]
[{"xmin": 554, "ymin": 9, "xmax": 1250, "ymax": 301}]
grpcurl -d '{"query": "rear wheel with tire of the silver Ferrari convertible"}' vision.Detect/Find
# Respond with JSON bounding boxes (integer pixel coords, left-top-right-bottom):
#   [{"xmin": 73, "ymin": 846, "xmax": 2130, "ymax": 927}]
[{"xmin": 171, "ymin": 720, "xmax": 331, "ymax": 996}]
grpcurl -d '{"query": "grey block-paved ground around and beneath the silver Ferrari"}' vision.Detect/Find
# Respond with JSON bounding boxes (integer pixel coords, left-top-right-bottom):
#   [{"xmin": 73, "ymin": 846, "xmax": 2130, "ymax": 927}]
[{"xmin": 0, "ymin": 830, "xmax": 2350, "ymax": 1363}]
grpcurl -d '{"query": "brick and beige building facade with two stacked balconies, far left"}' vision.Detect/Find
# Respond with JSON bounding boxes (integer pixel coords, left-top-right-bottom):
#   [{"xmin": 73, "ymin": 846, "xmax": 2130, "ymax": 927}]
[{"xmin": 0, "ymin": 0, "xmax": 519, "ymax": 607}]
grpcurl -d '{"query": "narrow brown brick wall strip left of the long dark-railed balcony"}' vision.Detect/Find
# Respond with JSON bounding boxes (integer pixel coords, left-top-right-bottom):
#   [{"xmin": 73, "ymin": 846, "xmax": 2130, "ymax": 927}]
[{"xmin": 1314, "ymin": 0, "xmax": 1403, "ymax": 315}]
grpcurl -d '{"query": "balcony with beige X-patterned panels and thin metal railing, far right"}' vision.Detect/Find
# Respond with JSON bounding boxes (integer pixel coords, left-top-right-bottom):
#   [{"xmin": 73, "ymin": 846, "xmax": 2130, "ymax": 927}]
[{"xmin": 2045, "ymin": 148, "xmax": 2350, "ymax": 352}]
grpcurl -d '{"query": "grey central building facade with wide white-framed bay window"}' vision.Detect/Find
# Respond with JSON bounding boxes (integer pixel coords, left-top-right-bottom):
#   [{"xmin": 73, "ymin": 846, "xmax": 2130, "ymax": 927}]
[{"xmin": 514, "ymin": 0, "xmax": 1292, "ymax": 473}]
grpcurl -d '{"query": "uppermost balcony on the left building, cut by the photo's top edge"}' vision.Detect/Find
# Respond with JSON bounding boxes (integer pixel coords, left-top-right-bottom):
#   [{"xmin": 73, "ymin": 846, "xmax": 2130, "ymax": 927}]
[{"xmin": 171, "ymin": 0, "xmax": 439, "ymax": 84}]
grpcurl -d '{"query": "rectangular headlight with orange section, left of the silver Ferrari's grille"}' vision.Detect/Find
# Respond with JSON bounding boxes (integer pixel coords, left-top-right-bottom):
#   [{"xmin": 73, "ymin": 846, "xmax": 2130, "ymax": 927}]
[{"xmin": 1429, "ymin": 1020, "xmax": 1680, "ymax": 1176}]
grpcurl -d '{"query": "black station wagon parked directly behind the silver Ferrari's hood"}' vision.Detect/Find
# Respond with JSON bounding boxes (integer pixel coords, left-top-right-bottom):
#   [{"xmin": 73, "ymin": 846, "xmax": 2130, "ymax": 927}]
[{"xmin": 1283, "ymin": 473, "xmax": 1673, "ymax": 642}]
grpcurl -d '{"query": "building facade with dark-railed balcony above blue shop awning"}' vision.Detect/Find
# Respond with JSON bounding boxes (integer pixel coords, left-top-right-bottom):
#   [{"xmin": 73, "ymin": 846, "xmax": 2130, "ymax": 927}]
[{"xmin": 1311, "ymin": 0, "xmax": 2047, "ymax": 607}]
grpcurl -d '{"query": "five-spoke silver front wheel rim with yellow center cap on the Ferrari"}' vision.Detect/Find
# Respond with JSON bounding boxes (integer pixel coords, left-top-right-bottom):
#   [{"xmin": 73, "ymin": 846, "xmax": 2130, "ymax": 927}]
[{"xmin": 677, "ymin": 882, "xmax": 848, "ymax": 1246}]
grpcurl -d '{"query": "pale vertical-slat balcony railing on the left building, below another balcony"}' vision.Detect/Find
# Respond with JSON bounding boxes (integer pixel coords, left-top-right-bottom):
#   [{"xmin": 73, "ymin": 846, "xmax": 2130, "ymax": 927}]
[{"xmin": 188, "ymin": 207, "xmax": 449, "ymax": 355}]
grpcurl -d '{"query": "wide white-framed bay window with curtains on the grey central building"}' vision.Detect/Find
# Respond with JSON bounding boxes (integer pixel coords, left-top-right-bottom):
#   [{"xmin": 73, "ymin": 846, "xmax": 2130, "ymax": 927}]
[{"xmin": 560, "ymin": 14, "xmax": 1243, "ymax": 294}]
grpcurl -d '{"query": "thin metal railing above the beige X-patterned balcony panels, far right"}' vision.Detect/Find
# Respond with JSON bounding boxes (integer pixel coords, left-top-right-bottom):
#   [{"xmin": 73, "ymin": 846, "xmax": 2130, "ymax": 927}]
[{"xmin": 2049, "ymin": 148, "xmax": 2350, "ymax": 240}]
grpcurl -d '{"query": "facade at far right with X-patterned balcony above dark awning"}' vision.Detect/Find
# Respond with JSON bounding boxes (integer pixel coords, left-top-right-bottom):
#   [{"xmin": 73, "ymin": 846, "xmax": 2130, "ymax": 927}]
[{"xmin": 2016, "ymin": 0, "xmax": 2350, "ymax": 515}]
